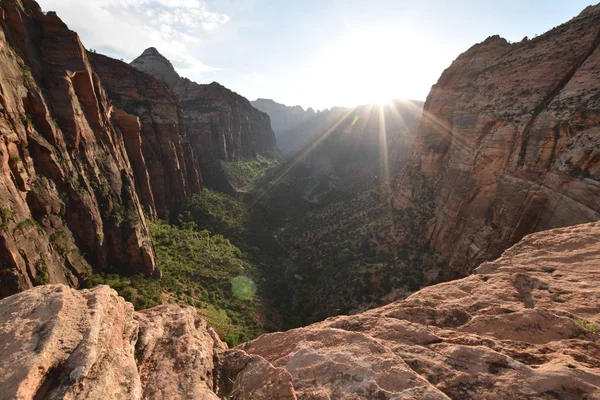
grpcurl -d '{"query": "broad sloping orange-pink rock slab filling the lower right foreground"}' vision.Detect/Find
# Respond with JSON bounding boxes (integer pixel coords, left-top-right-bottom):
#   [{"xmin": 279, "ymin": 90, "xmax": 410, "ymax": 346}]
[{"xmin": 239, "ymin": 223, "xmax": 600, "ymax": 400}]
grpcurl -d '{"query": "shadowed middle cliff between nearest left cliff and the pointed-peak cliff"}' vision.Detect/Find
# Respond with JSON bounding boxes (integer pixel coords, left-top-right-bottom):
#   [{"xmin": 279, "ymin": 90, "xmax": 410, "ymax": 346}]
[{"xmin": 88, "ymin": 53, "xmax": 202, "ymax": 218}]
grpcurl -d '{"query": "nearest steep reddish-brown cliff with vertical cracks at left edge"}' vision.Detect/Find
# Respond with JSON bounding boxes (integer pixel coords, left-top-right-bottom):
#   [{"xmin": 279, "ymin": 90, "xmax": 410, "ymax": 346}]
[{"xmin": 0, "ymin": 0, "xmax": 157, "ymax": 297}]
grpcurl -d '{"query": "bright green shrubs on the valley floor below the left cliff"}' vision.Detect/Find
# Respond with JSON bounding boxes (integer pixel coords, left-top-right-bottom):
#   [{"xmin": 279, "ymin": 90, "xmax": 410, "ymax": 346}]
[{"xmin": 86, "ymin": 221, "xmax": 262, "ymax": 346}]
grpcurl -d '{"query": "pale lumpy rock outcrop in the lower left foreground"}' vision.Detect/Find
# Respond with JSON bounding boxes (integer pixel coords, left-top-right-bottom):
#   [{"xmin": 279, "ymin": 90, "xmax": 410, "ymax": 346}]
[{"xmin": 0, "ymin": 285, "xmax": 295, "ymax": 400}]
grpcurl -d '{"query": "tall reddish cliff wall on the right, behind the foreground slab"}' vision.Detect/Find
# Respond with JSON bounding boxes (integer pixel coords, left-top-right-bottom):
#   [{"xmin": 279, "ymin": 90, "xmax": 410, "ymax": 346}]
[{"xmin": 393, "ymin": 6, "xmax": 600, "ymax": 274}]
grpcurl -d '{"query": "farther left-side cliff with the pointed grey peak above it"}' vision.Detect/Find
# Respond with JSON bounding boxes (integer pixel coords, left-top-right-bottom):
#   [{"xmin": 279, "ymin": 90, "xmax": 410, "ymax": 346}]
[{"xmin": 131, "ymin": 48, "xmax": 275, "ymax": 188}]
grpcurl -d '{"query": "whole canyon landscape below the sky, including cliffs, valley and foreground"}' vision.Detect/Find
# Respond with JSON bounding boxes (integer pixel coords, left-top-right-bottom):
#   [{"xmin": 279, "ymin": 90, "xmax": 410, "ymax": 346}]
[{"xmin": 0, "ymin": 0, "xmax": 600, "ymax": 400}]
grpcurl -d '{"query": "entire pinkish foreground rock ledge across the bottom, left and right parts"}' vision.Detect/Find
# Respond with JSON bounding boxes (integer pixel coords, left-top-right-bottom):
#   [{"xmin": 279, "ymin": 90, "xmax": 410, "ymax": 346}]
[{"xmin": 0, "ymin": 223, "xmax": 600, "ymax": 400}]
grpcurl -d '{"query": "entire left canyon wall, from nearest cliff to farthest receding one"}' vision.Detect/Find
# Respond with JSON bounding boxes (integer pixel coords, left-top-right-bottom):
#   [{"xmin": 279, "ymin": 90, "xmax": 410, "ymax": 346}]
[{"xmin": 0, "ymin": 0, "xmax": 275, "ymax": 297}]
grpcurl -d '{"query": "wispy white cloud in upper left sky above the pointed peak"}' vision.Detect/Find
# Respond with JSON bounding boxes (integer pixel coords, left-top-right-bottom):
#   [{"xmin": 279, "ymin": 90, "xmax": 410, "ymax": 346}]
[{"xmin": 38, "ymin": 0, "xmax": 230, "ymax": 77}]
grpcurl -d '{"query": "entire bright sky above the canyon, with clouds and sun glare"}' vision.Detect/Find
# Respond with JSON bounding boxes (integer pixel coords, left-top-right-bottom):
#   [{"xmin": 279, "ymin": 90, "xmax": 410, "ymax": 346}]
[{"xmin": 38, "ymin": 0, "xmax": 593, "ymax": 109}]
